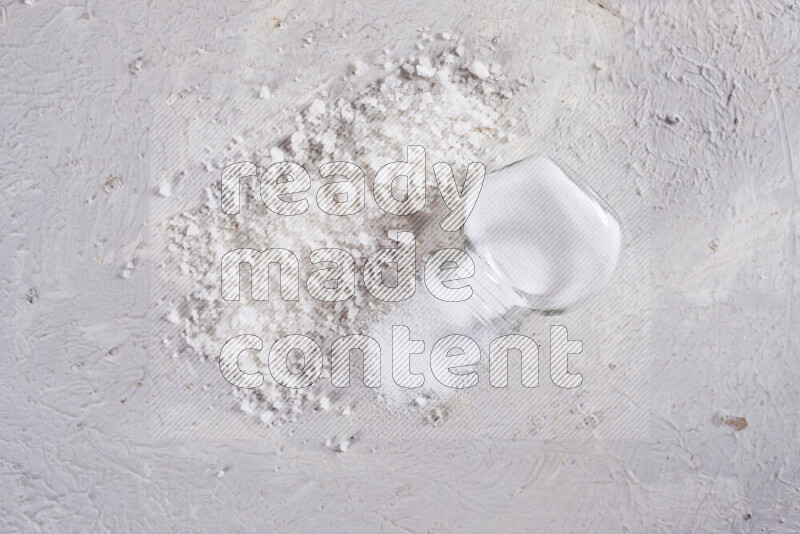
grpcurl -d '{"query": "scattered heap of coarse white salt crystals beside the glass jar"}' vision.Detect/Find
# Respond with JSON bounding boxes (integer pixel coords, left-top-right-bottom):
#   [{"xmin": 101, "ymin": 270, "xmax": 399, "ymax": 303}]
[{"xmin": 161, "ymin": 36, "xmax": 526, "ymax": 432}]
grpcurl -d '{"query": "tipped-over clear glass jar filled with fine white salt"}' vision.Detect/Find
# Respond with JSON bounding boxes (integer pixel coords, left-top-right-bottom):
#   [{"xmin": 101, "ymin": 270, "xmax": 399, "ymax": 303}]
[{"xmin": 464, "ymin": 155, "xmax": 622, "ymax": 329}]
